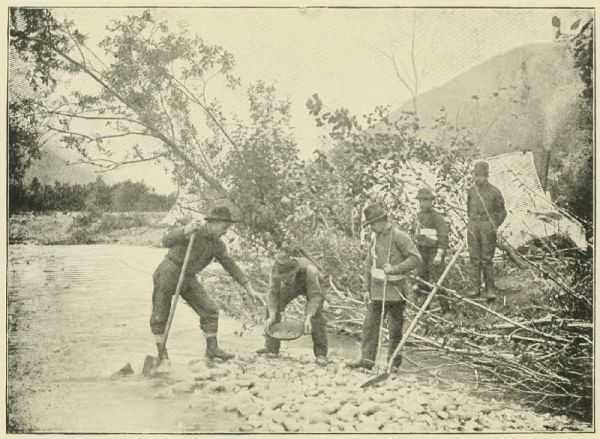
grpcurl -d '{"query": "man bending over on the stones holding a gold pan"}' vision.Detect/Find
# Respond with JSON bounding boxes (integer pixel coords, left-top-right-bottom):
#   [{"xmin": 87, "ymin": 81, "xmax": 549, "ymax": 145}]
[{"xmin": 257, "ymin": 252, "xmax": 327, "ymax": 366}]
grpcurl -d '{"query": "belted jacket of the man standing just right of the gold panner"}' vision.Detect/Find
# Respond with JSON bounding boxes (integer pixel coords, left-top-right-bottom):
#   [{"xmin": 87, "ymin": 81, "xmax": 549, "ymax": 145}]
[{"xmin": 363, "ymin": 224, "xmax": 422, "ymax": 291}]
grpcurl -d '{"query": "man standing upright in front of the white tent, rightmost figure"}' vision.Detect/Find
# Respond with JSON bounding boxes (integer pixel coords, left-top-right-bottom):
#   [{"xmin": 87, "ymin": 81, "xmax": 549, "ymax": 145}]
[{"xmin": 467, "ymin": 161, "xmax": 506, "ymax": 300}]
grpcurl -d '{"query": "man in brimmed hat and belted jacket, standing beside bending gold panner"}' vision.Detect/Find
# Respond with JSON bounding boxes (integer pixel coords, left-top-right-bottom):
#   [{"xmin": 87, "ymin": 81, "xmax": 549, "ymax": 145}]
[{"xmin": 348, "ymin": 204, "xmax": 421, "ymax": 369}]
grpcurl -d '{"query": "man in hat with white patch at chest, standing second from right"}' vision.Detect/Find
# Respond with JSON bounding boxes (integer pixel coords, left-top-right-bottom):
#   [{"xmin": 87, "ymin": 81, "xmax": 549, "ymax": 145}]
[{"xmin": 410, "ymin": 188, "xmax": 450, "ymax": 314}]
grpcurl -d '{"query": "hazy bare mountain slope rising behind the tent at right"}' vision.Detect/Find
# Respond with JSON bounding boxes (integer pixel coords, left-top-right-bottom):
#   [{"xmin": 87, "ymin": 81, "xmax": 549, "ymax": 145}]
[{"xmin": 392, "ymin": 42, "xmax": 583, "ymax": 177}]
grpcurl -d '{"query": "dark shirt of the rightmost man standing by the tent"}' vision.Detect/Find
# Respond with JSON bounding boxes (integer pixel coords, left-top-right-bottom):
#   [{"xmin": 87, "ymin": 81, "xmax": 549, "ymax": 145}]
[{"xmin": 467, "ymin": 181, "xmax": 506, "ymax": 228}]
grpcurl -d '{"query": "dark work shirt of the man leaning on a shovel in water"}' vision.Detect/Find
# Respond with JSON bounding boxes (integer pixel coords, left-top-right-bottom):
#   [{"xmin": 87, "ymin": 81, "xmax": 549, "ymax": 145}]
[{"xmin": 162, "ymin": 224, "xmax": 248, "ymax": 286}]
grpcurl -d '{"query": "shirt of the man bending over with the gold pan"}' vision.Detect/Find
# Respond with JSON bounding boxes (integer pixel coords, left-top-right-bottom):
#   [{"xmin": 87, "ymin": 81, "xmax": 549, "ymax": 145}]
[{"xmin": 267, "ymin": 258, "xmax": 325, "ymax": 317}]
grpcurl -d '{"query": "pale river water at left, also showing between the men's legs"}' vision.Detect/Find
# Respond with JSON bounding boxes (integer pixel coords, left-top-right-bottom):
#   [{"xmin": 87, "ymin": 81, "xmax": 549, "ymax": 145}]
[{"xmin": 7, "ymin": 245, "xmax": 358, "ymax": 433}]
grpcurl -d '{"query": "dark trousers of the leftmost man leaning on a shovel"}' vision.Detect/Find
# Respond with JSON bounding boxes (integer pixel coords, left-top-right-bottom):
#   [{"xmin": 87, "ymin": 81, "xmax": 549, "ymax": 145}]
[{"xmin": 150, "ymin": 259, "xmax": 219, "ymax": 335}]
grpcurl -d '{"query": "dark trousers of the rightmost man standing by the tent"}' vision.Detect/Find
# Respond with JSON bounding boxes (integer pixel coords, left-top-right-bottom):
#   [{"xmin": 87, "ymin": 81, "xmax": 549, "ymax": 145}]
[{"xmin": 467, "ymin": 219, "xmax": 497, "ymax": 289}]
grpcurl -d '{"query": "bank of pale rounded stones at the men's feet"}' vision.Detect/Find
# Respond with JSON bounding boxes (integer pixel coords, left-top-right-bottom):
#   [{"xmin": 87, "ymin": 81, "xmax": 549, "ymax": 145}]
[{"xmin": 149, "ymin": 355, "xmax": 590, "ymax": 433}]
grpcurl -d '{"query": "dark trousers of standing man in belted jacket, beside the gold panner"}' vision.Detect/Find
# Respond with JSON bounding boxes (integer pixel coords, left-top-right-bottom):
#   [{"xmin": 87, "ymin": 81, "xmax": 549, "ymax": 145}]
[{"xmin": 361, "ymin": 300, "xmax": 404, "ymax": 365}]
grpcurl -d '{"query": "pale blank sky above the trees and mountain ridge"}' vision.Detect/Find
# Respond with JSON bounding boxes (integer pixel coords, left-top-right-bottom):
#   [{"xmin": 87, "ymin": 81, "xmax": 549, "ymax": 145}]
[{"xmin": 42, "ymin": 8, "xmax": 585, "ymax": 193}]
